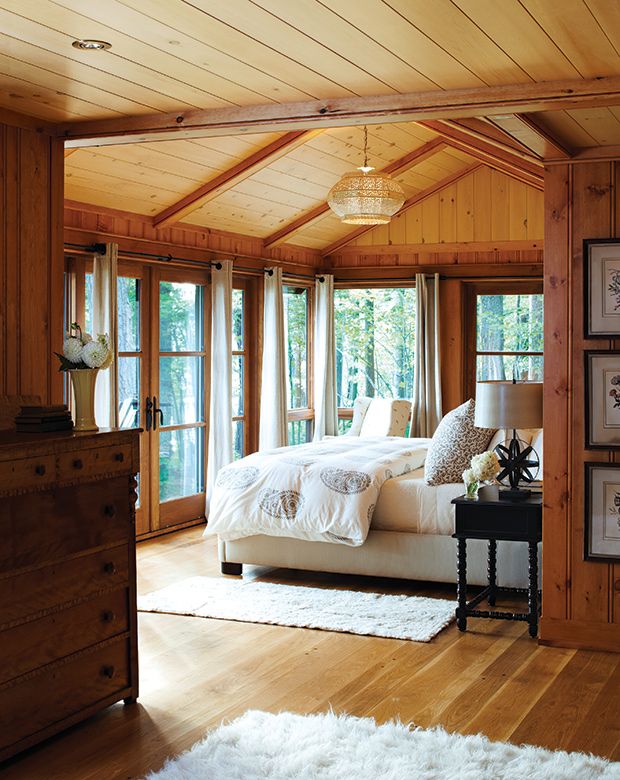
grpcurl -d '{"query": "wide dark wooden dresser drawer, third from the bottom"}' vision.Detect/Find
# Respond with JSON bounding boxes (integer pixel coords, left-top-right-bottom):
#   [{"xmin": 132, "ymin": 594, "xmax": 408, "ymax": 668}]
[{"xmin": 0, "ymin": 544, "xmax": 129, "ymax": 630}]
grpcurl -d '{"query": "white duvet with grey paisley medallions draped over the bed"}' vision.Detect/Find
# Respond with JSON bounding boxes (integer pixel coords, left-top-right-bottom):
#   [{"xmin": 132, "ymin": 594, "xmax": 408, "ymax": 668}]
[{"xmin": 205, "ymin": 436, "xmax": 429, "ymax": 547}]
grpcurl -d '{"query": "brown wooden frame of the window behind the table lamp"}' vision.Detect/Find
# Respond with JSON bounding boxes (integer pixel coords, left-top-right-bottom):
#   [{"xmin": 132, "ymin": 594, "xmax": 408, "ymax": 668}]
[{"xmin": 463, "ymin": 278, "xmax": 544, "ymax": 398}]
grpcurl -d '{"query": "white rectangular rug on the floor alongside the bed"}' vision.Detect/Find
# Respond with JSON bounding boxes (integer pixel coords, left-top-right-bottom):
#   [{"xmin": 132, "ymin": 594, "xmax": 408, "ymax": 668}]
[{"xmin": 138, "ymin": 577, "xmax": 456, "ymax": 642}]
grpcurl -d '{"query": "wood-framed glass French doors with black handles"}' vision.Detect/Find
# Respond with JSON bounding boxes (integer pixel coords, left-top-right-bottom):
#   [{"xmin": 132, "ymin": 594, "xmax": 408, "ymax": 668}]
[{"xmin": 118, "ymin": 263, "xmax": 209, "ymax": 536}]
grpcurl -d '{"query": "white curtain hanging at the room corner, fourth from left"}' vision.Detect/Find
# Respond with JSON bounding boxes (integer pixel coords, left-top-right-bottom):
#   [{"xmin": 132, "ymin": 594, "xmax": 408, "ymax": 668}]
[{"xmin": 314, "ymin": 274, "xmax": 338, "ymax": 441}]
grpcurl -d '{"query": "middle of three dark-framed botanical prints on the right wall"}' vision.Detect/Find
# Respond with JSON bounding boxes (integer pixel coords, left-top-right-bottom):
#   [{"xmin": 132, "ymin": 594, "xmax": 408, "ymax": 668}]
[{"xmin": 585, "ymin": 350, "xmax": 620, "ymax": 450}]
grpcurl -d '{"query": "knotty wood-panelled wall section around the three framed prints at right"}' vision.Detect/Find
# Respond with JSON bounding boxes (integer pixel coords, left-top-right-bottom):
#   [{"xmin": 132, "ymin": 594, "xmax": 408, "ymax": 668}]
[{"xmin": 540, "ymin": 161, "xmax": 620, "ymax": 651}]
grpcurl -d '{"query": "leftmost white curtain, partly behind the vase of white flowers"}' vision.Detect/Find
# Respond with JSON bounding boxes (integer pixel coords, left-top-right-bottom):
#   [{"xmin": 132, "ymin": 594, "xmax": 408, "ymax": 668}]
[{"xmin": 92, "ymin": 244, "xmax": 118, "ymax": 428}]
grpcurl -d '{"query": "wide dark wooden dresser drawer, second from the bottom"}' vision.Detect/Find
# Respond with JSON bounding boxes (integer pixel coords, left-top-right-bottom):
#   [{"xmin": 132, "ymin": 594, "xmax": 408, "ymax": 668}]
[{"xmin": 0, "ymin": 588, "xmax": 129, "ymax": 685}]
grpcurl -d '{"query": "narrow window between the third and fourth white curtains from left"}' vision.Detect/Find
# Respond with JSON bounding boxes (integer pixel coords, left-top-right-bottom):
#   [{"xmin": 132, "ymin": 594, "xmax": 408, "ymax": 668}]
[{"xmin": 283, "ymin": 285, "xmax": 314, "ymax": 444}]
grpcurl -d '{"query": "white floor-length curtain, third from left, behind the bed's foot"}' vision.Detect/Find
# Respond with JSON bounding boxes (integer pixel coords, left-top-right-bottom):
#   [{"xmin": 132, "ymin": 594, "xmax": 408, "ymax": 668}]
[{"xmin": 259, "ymin": 268, "xmax": 288, "ymax": 450}]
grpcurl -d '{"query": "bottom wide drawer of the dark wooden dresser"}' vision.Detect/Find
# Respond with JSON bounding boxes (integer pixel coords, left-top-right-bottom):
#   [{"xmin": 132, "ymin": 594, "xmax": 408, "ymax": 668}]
[{"xmin": 0, "ymin": 638, "xmax": 130, "ymax": 754}]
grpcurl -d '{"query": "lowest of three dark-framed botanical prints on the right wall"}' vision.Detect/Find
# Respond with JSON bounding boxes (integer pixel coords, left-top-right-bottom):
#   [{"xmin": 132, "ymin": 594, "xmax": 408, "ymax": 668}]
[{"xmin": 584, "ymin": 463, "xmax": 620, "ymax": 563}]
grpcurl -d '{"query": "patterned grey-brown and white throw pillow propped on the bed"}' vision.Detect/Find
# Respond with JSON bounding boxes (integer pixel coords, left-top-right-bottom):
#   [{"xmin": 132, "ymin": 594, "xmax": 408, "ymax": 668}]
[{"xmin": 424, "ymin": 398, "xmax": 495, "ymax": 485}]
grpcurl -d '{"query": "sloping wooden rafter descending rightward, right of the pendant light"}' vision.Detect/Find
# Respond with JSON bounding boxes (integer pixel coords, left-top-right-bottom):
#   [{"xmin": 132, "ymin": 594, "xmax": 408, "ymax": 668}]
[{"xmin": 420, "ymin": 120, "xmax": 543, "ymax": 190}]
